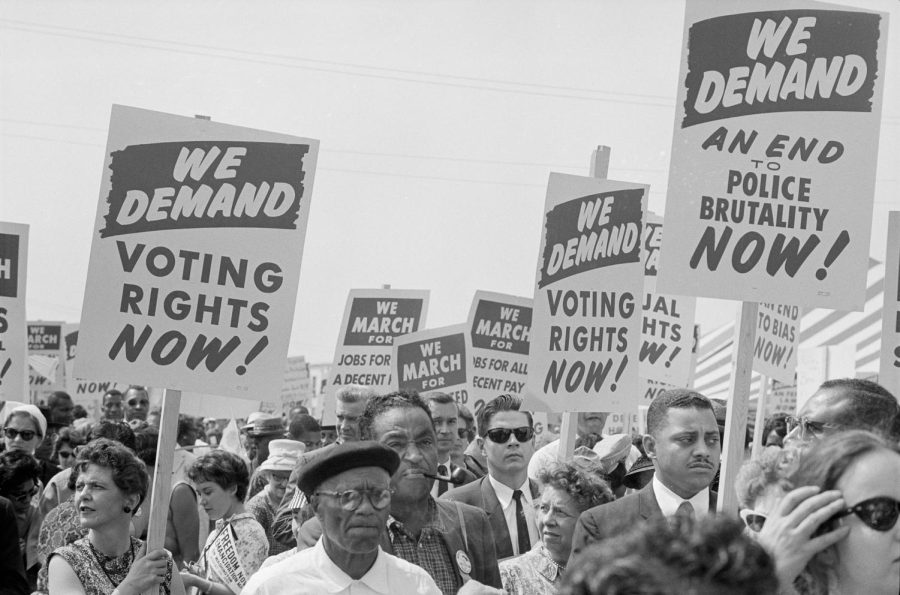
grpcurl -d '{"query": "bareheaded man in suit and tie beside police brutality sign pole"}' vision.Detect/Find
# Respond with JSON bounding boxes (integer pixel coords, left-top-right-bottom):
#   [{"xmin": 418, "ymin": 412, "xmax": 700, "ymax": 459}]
[{"xmin": 570, "ymin": 389, "xmax": 722, "ymax": 561}]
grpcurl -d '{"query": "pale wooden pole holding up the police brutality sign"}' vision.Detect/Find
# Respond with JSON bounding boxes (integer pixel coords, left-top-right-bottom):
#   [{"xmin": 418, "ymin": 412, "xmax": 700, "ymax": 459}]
[{"xmin": 716, "ymin": 302, "xmax": 759, "ymax": 517}]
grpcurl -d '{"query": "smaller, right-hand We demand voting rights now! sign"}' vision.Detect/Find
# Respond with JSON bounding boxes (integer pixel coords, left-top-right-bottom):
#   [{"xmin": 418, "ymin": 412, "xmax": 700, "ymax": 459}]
[{"xmin": 525, "ymin": 173, "xmax": 647, "ymax": 414}]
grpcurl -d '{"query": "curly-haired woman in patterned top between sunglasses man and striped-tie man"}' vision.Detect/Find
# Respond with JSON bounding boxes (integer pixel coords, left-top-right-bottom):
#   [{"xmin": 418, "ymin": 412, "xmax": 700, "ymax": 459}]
[{"xmin": 500, "ymin": 463, "xmax": 615, "ymax": 595}]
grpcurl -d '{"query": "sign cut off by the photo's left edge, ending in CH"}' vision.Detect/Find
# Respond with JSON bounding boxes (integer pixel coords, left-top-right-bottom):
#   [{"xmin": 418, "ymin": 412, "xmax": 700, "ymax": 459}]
[{"xmin": 0, "ymin": 221, "xmax": 28, "ymax": 402}]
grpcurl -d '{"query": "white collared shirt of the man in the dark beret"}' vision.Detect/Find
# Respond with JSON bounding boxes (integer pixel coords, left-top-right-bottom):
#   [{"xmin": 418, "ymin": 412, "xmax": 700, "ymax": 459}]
[{"xmin": 241, "ymin": 539, "xmax": 441, "ymax": 595}]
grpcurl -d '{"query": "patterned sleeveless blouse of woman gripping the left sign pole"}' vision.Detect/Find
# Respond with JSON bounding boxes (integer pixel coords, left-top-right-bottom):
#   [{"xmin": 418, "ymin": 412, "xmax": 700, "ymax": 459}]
[{"xmin": 50, "ymin": 537, "xmax": 175, "ymax": 595}]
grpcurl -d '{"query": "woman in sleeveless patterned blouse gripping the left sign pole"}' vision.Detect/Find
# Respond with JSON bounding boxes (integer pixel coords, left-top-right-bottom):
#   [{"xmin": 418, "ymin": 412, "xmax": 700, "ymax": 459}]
[{"xmin": 48, "ymin": 438, "xmax": 184, "ymax": 595}]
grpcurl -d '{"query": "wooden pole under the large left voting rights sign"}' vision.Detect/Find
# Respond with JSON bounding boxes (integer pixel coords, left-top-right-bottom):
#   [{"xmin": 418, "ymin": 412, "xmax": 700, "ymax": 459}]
[{"xmin": 144, "ymin": 388, "xmax": 181, "ymax": 595}]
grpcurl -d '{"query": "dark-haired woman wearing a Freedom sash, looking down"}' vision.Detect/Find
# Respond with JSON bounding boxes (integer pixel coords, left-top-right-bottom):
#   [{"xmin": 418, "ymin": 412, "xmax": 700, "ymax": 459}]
[{"xmin": 181, "ymin": 449, "xmax": 269, "ymax": 595}]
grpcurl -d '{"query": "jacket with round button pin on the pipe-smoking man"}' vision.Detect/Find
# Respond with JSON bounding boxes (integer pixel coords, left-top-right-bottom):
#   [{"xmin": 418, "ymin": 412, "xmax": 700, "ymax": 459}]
[{"xmin": 297, "ymin": 496, "xmax": 502, "ymax": 595}]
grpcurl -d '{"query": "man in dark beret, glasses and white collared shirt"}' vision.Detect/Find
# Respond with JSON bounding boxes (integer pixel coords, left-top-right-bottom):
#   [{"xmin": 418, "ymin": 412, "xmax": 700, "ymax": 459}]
[{"xmin": 242, "ymin": 442, "xmax": 440, "ymax": 595}]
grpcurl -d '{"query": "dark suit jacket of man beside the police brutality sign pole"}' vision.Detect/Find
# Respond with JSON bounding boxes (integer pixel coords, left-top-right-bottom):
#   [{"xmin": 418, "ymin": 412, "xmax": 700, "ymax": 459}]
[{"xmin": 569, "ymin": 482, "xmax": 718, "ymax": 564}]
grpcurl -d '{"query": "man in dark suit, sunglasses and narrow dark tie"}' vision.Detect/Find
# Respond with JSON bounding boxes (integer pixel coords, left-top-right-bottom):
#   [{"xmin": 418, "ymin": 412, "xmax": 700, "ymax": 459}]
[{"xmin": 443, "ymin": 395, "xmax": 540, "ymax": 559}]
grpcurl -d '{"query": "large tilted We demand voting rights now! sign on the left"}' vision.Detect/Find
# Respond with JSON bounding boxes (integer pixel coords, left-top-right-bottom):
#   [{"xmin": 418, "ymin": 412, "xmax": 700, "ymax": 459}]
[{"xmin": 75, "ymin": 106, "xmax": 318, "ymax": 399}]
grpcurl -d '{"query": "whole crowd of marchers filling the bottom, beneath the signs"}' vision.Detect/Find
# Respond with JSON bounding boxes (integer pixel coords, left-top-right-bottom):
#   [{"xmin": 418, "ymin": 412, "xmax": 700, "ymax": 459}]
[{"xmin": 0, "ymin": 379, "xmax": 900, "ymax": 595}]
